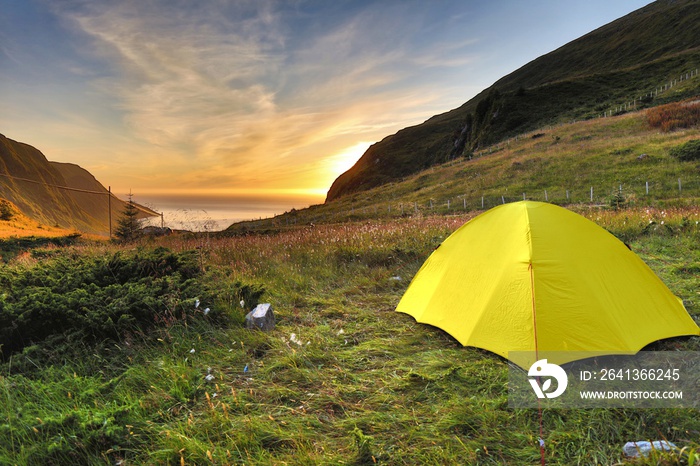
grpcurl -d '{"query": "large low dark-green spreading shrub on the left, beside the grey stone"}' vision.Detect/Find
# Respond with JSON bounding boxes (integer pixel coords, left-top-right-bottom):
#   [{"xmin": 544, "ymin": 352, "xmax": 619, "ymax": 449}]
[{"xmin": 0, "ymin": 248, "xmax": 260, "ymax": 357}]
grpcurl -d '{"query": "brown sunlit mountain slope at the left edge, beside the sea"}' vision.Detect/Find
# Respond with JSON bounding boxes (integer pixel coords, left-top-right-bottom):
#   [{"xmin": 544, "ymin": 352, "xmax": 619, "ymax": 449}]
[{"xmin": 0, "ymin": 134, "xmax": 157, "ymax": 235}]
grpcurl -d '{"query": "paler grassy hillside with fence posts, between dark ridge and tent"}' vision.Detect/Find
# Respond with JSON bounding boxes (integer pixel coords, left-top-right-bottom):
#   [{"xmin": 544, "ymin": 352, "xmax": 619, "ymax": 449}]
[{"xmin": 228, "ymin": 100, "xmax": 700, "ymax": 233}]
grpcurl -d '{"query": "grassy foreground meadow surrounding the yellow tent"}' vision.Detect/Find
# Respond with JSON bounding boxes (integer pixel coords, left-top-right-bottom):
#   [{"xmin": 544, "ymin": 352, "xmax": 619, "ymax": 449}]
[{"xmin": 0, "ymin": 207, "xmax": 700, "ymax": 465}]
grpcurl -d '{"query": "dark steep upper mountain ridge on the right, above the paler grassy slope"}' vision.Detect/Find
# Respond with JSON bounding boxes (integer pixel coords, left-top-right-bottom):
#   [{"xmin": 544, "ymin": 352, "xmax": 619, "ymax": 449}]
[{"xmin": 326, "ymin": 0, "xmax": 700, "ymax": 202}]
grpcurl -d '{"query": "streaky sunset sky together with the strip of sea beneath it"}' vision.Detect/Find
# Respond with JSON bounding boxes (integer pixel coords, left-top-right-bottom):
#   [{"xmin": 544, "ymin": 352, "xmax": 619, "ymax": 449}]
[{"xmin": 0, "ymin": 0, "xmax": 649, "ymax": 226}]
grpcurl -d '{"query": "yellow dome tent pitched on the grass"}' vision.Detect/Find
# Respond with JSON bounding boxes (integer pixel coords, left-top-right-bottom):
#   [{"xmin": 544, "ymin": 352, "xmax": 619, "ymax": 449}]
[{"xmin": 396, "ymin": 201, "xmax": 700, "ymax": 369}]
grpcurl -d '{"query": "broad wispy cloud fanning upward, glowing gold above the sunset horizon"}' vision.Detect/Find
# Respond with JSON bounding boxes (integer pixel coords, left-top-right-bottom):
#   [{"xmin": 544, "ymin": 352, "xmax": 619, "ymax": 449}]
[{"xmin": 43, "ymin": 0, "xmax": 484, "ymax": 194}]
